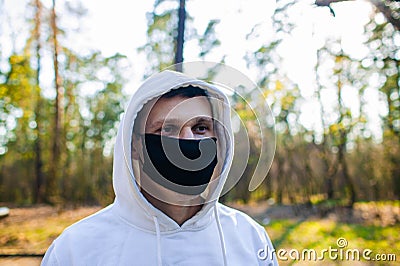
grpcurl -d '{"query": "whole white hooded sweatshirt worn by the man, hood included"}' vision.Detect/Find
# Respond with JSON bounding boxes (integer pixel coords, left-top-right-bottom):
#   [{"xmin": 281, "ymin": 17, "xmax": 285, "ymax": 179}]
[{"xmin": 42, "ymin": 71, "xmax": 277, "ymax": 266}]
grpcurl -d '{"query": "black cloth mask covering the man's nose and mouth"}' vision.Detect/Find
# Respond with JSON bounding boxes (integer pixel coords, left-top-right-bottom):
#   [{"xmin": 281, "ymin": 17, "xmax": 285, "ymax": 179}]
[{"xmin": 139, "ymin": 134, "xmax": 217, "ymax": 195}]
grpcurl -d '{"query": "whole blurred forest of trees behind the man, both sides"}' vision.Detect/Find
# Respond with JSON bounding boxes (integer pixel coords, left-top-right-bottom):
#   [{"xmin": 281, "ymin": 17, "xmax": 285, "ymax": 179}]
[{"xmin": 0, "ymin": 0, "xmax": 400, "ymax": 206}]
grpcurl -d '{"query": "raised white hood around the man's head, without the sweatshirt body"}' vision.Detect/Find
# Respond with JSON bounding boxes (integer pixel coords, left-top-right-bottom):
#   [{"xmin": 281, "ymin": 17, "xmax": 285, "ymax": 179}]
[{"xmin": 113, "ymin": 71, "xmax": 234, "ymax": 232}]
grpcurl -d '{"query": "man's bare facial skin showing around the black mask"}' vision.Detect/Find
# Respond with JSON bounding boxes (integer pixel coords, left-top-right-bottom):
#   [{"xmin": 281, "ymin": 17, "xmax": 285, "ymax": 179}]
[{"xmin": 132, "ymin": 96, "xmax": 215, "ymax": 202}]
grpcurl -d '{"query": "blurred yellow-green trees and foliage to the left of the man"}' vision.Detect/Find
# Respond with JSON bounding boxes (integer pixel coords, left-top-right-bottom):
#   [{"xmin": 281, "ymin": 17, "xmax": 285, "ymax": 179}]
[{"xmin": 0, "ymin": 1, "xmax": 128, "ymax": 204}]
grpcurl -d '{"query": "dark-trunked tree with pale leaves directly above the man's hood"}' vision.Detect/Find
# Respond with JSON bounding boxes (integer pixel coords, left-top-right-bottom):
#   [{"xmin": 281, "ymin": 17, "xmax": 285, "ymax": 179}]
[{"xmin": 138, "ymin": 0, "xmax": 220, "ymax": 76}]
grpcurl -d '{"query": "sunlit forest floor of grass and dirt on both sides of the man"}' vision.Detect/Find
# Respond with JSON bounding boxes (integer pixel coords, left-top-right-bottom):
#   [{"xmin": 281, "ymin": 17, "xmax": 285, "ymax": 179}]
[{"xmin": 0, "ymin": 202, "xmax": 400, "ymax": 266}]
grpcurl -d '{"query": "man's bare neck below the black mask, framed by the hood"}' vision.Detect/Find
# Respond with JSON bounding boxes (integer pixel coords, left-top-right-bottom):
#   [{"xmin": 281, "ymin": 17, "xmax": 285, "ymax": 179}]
[{"xmin": 141, "ymin": 189, "xmax": 203, "ymax": 226}]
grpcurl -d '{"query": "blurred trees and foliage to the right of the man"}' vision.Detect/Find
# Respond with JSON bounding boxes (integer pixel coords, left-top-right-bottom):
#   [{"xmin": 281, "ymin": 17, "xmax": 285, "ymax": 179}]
[{"xmin": 238, "ymin": 1, "xmax": 400, "ymax": 205}]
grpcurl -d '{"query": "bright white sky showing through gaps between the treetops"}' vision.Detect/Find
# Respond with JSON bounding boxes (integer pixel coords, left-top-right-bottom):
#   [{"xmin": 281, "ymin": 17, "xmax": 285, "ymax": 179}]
[{"xmin": 0, "ymin": 0, "xmax": 382, "ymax": 140}]
